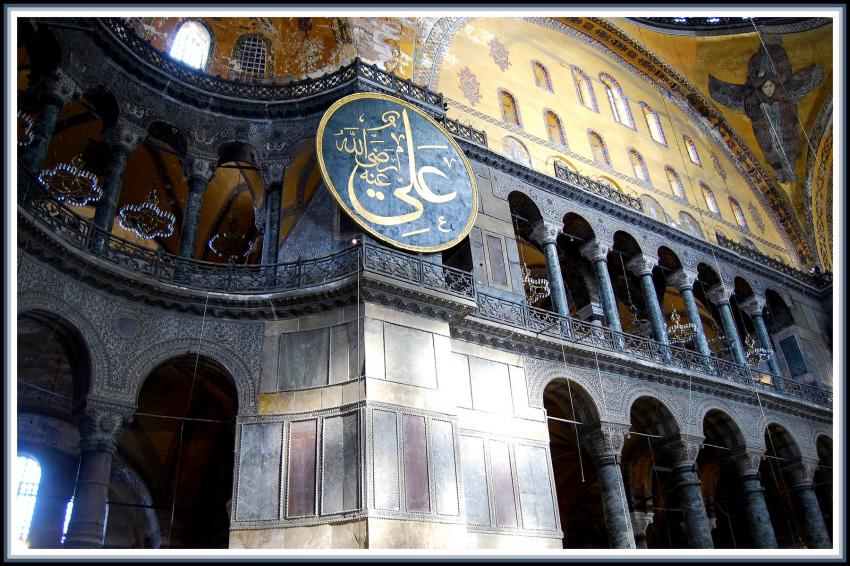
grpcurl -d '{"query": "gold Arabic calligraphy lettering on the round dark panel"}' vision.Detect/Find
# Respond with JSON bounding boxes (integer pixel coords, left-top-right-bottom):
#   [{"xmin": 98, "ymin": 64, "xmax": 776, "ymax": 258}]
[{"xmin": 334, "ymin": 109, "xmax": 457, "ymax": 231}]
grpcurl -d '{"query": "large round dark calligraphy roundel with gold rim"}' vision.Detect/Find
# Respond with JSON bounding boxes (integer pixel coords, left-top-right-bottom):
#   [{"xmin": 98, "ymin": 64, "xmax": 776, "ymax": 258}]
[{"xmin": 316, "ymin": 93, "xmax": 478, "ymax": 252}]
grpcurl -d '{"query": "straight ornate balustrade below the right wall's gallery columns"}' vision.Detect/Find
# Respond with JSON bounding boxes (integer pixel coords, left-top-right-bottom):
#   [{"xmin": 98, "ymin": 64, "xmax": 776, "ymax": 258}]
[{"xmin": 474, "ymin": 293, "xmax": 832, "ymax": 407}]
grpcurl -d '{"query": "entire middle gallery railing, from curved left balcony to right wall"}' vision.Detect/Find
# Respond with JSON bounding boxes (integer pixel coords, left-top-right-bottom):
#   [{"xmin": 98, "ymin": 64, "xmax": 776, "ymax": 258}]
[{"xmin": 18, "ymin": 168, "xmax": 832, "ymax": 407}]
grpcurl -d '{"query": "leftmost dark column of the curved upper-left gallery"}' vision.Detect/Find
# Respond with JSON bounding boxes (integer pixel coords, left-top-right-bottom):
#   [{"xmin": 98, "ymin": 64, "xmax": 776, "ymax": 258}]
[{"xmin": 20, "ymin": 69, "xmax": 77, "ymax": 175}]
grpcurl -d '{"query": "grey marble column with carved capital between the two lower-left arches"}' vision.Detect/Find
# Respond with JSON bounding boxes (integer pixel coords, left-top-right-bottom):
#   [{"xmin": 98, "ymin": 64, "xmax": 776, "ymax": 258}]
[{"xmin": 65, "ymin": 404, "xmax": 133, "ymax": 548}]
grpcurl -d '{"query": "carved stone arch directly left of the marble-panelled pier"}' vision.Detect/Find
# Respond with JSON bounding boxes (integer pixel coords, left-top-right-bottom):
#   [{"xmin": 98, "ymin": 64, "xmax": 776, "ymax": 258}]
[{"xmin": 127, "ymin": 338, "xmax": 257, "ymax": 416}]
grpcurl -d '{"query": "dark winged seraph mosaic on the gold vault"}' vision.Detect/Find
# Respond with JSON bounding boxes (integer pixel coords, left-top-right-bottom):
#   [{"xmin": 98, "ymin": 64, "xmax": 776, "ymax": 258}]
[{"xmin": 708, "ymin": 36, "xmax": 824, "ymax": 183}]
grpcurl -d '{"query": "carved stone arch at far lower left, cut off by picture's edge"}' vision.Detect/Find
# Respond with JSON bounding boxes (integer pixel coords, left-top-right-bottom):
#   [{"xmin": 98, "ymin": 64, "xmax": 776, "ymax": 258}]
[{"xmin": 18, "ymin": 291, "xmax": 114, "ymax": 404}]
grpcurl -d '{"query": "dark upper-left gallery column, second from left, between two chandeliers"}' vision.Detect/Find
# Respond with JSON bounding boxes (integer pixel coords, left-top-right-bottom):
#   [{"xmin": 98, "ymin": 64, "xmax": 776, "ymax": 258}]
[{"xmin": 92, "ymin": 120, "xmax": 147, "ymax": 251}]
